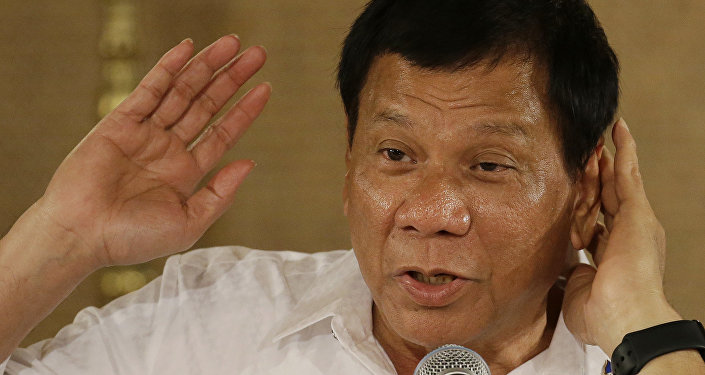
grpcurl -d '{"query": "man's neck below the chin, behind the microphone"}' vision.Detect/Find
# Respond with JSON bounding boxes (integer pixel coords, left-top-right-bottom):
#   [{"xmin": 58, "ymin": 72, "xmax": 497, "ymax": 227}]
[{"xmin": 373, "ymin": 288, "xmax": 562, "ymax": 375}]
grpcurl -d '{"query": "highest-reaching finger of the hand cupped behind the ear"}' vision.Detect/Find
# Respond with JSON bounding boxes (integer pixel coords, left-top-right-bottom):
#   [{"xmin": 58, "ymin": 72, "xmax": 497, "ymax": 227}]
[{"xmin": 612, "ymin": 119, "xmax": 645, "ymax": 204}]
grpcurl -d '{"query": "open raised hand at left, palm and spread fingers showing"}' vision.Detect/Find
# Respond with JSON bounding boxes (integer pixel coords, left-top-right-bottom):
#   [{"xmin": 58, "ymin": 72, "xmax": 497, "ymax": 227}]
[{"xmin": 35, "ymin": 35, "xmax": 271, "ymax": 267}]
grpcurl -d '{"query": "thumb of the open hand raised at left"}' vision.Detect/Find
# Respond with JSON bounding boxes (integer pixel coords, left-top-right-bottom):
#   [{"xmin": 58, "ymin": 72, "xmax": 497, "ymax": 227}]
[{"xmin": 186, "ymin": 160, "xmax": 255, "ymax": 241}]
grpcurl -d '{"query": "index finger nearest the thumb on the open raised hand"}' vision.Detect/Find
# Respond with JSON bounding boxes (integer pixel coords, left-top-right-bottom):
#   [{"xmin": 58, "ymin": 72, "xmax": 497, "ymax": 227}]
[{"xmin": 191, "ymin": 83, "xmax": 272, "ymax": 173}]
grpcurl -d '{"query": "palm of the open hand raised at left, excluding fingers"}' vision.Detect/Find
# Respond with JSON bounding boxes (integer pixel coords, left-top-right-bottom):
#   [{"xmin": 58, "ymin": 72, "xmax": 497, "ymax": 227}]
[{"xmin": 73, "ymin": 123, "xmax": 203, "ymax": 263}]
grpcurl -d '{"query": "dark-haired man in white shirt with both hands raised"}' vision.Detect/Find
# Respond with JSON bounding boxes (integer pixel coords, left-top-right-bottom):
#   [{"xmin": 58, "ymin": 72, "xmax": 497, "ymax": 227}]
[{"xmin": 0, "ymin": 0, "xmax": 705, "ymax": 374}]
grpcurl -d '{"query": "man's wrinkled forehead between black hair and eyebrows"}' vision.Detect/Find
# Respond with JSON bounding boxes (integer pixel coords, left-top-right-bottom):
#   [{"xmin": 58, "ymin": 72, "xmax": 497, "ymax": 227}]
[{"xmin": 359, "ymin": 54, "xmax": 554, "ymax": 137}]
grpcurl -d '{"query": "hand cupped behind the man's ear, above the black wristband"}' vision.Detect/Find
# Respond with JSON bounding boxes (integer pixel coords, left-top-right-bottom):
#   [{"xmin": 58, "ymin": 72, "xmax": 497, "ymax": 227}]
[{"xmin": 563, "ymin": 120, "xmax": 680, "ymax": 355}]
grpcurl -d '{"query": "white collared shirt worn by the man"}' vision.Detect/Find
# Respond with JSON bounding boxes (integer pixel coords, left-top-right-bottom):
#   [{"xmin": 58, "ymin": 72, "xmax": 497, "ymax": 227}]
[{"xmin": 0, "ymin": 247, "xmax": 607, "ymax": 375}]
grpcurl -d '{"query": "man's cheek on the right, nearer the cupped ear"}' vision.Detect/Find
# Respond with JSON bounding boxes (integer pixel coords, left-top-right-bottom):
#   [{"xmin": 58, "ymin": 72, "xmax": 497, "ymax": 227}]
[{"xmin": 475, "ymin": 173, "xmax": 572, "ymax": 294}]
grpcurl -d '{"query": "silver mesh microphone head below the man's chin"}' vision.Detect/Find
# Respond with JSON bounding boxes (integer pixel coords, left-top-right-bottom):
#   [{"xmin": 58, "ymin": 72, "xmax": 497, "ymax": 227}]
[{"xmin": 414, "ymin": 345, "xmax": 490, "ymax": 375}]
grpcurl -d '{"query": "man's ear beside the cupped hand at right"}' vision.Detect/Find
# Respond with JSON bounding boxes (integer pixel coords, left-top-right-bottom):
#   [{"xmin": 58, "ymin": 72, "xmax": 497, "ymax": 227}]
[{"xmin": 570, "ymin": 137, "xmax": 604, "ymax": 250}]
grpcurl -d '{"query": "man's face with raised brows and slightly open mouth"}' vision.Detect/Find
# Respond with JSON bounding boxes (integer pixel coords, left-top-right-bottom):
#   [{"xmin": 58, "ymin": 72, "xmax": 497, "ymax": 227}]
[{"xmin": 344, "ymin": 54, "xmax": 576, "ymax": 349}]
